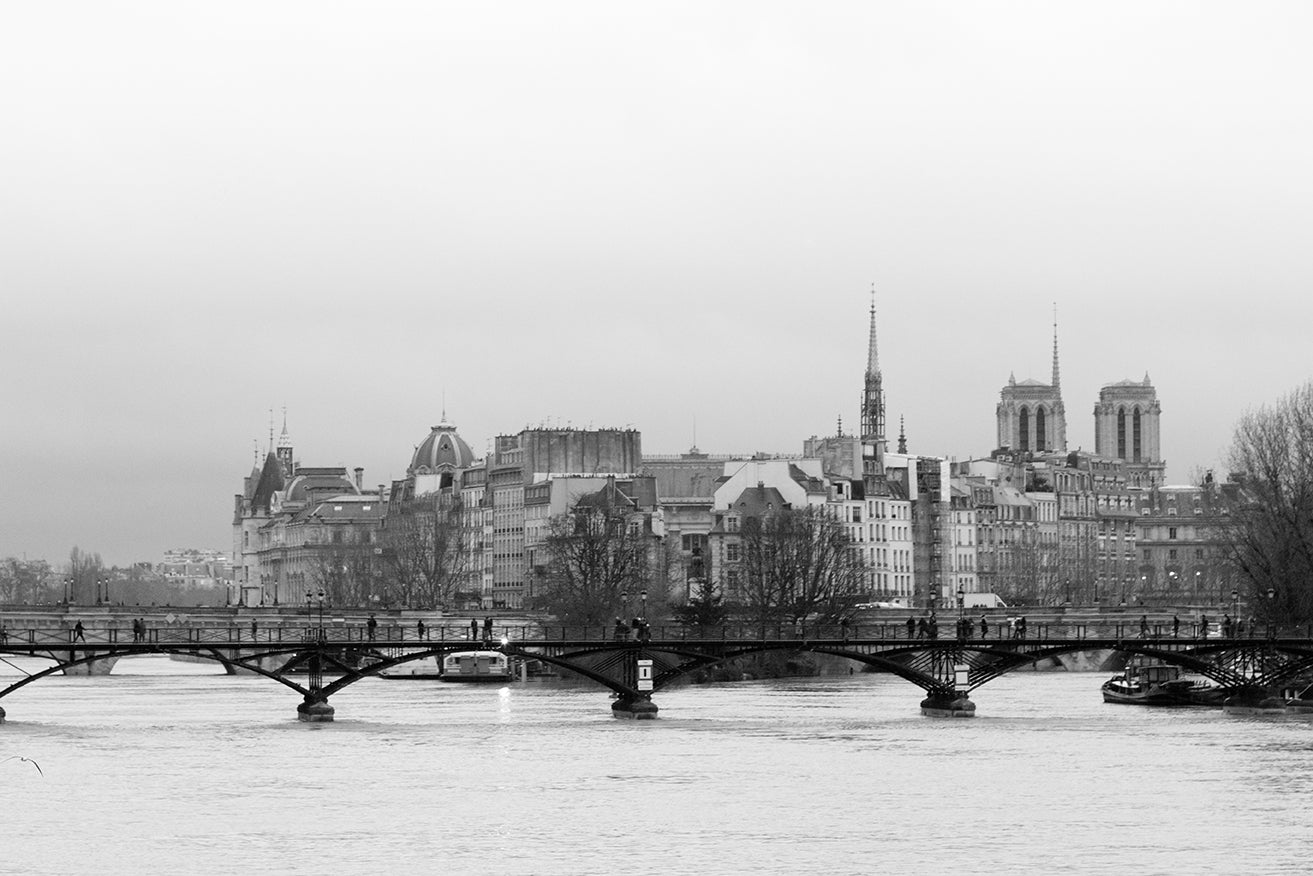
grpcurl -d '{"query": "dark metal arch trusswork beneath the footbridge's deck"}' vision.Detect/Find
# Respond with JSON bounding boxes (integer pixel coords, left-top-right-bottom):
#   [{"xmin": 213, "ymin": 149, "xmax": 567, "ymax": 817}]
[{"xmin": 0, "ymin": 638, "xmax": 1313, "ymax": 703}]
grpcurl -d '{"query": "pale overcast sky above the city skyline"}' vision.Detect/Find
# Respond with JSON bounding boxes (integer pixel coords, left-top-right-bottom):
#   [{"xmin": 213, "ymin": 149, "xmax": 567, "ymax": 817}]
[{"xmin": 0, "ymin": 0, "xmax": 1313, "ymax": 563}]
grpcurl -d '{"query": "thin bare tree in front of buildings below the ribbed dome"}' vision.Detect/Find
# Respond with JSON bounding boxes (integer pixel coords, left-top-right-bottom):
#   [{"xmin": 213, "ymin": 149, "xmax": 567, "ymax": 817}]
[{"xmin": 381, "ymin": 493, "xmax": 470, "ymax": 607}]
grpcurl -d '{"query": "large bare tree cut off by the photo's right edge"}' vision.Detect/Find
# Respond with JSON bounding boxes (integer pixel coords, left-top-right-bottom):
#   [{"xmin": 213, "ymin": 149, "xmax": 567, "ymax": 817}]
[{"xmin": 1220, "ymin": 381, "xmax": 1313, "ymax": 624}]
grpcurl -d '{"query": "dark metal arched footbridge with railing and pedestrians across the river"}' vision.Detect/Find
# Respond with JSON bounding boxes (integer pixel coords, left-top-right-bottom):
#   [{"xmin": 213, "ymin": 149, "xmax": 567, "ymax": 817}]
[{"xmin": 0, "ymin": 624, "xmax": 1313, "ymax": 721}]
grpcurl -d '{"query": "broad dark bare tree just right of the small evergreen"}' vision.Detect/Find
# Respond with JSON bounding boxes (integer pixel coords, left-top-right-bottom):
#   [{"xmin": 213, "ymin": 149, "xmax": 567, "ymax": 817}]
[{"xmin": 739, "ymin": 506, "xmax": 867, "ymax": 625}]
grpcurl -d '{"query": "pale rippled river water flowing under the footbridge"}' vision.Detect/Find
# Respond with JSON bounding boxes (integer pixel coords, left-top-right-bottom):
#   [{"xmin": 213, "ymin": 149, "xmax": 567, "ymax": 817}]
[{"xmin": 0, "ymin": 657, "xmax": 1313, "ymax": 876}]
